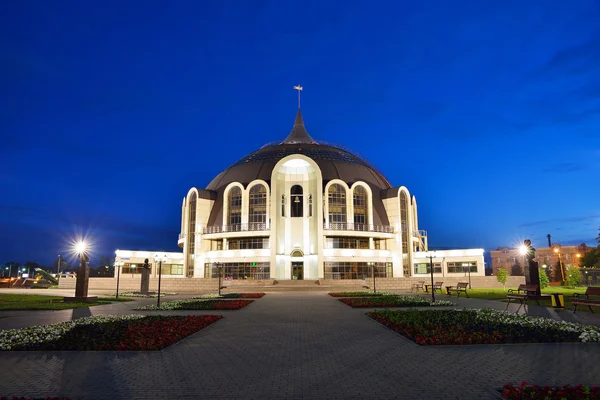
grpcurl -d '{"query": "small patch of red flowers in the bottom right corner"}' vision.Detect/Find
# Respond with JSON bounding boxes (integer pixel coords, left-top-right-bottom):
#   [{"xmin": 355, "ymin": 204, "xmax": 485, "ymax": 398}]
[{"xmin": 502, "ymin": 382, "xmax": 600, "ymax": 400}]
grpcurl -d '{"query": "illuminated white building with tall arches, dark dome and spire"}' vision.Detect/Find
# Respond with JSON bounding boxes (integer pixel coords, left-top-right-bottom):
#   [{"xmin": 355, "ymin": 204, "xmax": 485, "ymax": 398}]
[{"xmin": 178, "ymin": 109, "xmax": 484, "ymax": 281}]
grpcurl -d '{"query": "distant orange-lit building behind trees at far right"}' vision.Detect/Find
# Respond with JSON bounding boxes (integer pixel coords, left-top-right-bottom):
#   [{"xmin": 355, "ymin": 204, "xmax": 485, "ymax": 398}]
[{"xmin": 490, "ymin": 243, "xmax": 593, "ymax": 275}]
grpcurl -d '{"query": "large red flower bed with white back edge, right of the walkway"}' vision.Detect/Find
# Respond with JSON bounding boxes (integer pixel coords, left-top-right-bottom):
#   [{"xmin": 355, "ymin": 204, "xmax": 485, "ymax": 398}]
[{"xmin": 367, "ymin": 309, "xmax": 600, "ymax": 345}]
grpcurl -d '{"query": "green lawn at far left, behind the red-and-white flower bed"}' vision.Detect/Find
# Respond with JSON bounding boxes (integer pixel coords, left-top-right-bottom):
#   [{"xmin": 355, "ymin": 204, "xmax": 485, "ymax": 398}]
[{"xmin": 0, "ymin": 294, "xmax": 131, "ymax": 311}]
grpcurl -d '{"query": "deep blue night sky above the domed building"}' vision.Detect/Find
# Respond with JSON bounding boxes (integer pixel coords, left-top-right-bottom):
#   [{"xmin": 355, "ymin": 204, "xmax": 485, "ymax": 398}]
[{"xmin": 0, "ymin": 0, "xmax": 600, "ymax": 265}]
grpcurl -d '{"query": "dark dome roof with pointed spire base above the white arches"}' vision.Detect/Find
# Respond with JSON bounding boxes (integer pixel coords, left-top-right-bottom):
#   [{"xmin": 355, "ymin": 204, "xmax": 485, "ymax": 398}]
[{"xmin": 206, "ymin": 110, "xmax": 391, "ymax": 191}]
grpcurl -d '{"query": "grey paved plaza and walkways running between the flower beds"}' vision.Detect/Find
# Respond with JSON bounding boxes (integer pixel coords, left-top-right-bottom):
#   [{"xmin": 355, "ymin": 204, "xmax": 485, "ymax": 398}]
[{"xmin": 0, "ymin": 291, "xmax": 600, "ymax": 399}]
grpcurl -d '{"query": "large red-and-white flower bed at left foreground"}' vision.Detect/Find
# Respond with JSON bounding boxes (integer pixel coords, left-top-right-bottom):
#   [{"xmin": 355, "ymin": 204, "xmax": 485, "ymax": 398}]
[{"xmin": 0, "ymin": 315, "xmax": 223, "ymax": 350}]
